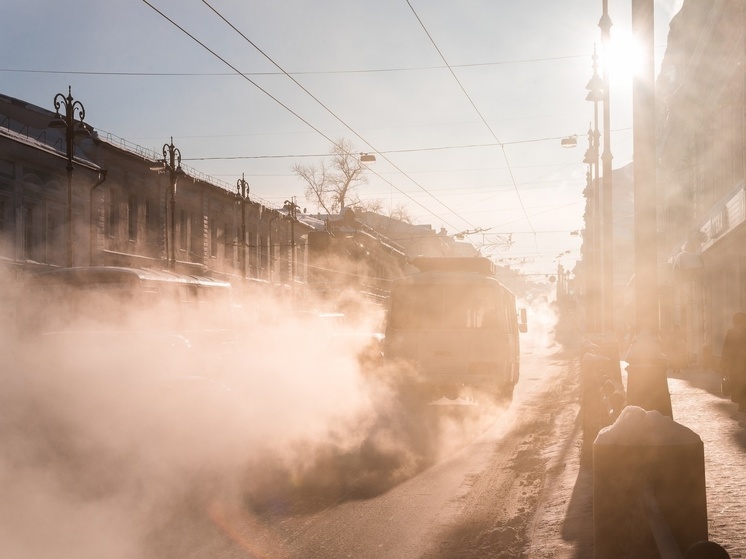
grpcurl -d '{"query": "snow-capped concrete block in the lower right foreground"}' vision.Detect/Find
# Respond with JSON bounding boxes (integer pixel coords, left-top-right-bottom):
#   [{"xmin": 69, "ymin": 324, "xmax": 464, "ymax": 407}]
[{"xmin": 593, "ymin": 406, "xmax": 708, "ymax": 559}]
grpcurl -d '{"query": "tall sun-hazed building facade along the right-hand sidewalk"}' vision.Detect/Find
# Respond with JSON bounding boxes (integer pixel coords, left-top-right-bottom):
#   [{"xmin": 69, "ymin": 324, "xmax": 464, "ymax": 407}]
[{"xmin": 656, "ymin": 0, "xmax": 746, "ymax": 366}]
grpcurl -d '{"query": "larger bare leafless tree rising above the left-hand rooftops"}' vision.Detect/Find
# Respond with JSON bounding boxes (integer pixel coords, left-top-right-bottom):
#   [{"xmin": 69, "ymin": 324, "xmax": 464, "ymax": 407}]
[{"xmin": 293, "ymin": 138, "xmax": 368, "ymax": 214}]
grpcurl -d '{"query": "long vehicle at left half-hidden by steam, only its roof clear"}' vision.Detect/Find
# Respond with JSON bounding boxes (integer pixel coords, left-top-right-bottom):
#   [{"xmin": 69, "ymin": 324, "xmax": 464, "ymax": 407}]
[{"xmin": 16, "ymin": 266, "xmax": 235, "ymax": 368}]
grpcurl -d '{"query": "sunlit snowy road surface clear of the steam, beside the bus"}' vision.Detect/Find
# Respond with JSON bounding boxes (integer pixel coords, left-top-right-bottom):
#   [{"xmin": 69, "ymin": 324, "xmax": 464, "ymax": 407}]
[{"xmin": 206, "ymin": 340, "xmax": 579, "ymax": 559}]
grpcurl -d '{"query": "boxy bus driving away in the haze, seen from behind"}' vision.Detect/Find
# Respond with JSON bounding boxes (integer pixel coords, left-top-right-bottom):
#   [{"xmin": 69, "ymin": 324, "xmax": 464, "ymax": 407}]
[{"xmin": 384, "ymin": 257, "xmax": 526, "ymax": 398}]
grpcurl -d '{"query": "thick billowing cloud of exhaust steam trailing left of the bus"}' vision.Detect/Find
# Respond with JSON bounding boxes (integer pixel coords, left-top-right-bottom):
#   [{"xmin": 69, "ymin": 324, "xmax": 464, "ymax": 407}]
[{"xmin": 0, "ymin": 286, "xmax": 516, "ymax": 559}]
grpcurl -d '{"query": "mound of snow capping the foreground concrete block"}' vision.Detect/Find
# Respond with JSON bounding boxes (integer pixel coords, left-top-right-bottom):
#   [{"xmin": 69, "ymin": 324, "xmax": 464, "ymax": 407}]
[{"xmin": 594, "ymin": 406, "xmax": 702, "ymax": 446}]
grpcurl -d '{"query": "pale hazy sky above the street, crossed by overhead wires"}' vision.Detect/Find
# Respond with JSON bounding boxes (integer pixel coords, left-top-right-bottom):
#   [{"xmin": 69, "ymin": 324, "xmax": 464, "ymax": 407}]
[{"xmin": 0, "ymin": 0, "xmax": 681, "ymax": 279}]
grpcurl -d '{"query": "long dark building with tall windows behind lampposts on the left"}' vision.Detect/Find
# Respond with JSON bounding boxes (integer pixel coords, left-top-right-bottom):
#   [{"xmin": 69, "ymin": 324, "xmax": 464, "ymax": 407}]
[{"xmin": 0, "ymin": 95, "xmax": 312, "ymax": 324}]
